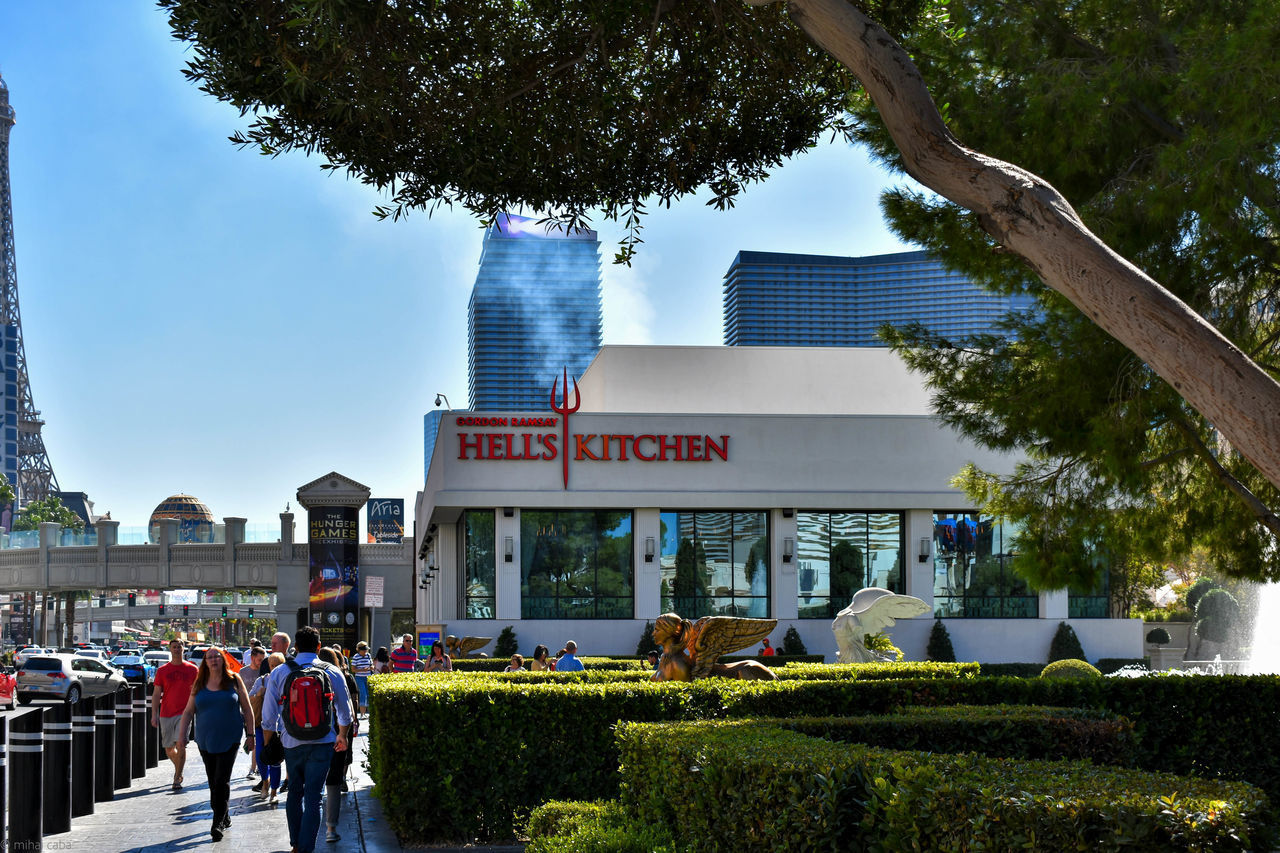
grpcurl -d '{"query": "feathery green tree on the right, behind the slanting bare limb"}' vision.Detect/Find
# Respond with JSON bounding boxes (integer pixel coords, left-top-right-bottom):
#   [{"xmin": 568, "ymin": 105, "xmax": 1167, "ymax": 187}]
[{"xmin": 870, "ymin": 0, "xmax": 1280, "ymax": 585}]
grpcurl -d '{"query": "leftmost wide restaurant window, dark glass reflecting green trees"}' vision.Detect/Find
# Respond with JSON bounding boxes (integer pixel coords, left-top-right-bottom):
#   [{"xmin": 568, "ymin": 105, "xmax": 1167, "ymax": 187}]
[{"xmin": 520, "ymin": 510, "xmax": 635, "ymax": 619}]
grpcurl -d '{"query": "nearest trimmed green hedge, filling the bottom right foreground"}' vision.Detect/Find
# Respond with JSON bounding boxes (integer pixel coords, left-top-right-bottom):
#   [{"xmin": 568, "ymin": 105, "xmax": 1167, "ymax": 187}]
[{"xmin": 618, "ymin": 722, "xmax": 1274, "ymax": 853}]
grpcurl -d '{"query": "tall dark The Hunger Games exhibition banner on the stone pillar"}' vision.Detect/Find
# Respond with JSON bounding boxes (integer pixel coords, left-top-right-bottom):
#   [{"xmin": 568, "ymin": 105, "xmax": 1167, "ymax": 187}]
[{"xmin": 307, "ymin": 506, "xmax": 360, "ymax": 651}]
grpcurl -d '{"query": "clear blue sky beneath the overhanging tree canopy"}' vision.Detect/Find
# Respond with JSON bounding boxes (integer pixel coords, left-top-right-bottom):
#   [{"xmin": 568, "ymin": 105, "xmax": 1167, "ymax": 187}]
[{"xmin": 0, "ymin": 0, "xmax": 909, "ymax": 524}]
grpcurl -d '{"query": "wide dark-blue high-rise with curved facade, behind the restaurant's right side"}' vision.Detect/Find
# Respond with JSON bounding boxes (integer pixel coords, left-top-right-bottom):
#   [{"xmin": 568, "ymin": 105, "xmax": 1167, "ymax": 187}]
[{"xmin": 724, "ymin": 251, "xmax": 1036, "ymax": 347}]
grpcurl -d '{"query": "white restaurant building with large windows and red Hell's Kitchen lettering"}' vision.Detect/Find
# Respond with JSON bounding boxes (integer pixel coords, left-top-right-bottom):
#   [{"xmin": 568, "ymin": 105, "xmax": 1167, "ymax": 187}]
[{"xmin": 416, "ymin": 346, "xmax": 1142, "ymax": 662}]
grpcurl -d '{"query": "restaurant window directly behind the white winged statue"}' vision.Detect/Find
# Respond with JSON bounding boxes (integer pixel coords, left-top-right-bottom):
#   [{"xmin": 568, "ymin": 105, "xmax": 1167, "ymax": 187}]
[{"xmin": 796, "ymin": 512, "xmax": 905, "ymax": 619}]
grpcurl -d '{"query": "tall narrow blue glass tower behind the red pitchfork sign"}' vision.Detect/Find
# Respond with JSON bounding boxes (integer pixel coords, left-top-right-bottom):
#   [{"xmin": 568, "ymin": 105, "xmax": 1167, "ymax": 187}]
[{"xmin": 467, "ymin": 215, "xmax": 600, "ymax": 411}]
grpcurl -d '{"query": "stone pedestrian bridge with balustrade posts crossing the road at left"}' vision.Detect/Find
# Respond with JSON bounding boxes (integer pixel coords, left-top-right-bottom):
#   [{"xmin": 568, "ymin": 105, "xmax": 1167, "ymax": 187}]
[{"xmin": 0, "ymin": 512, "xmax": 413, "ymax": 591}]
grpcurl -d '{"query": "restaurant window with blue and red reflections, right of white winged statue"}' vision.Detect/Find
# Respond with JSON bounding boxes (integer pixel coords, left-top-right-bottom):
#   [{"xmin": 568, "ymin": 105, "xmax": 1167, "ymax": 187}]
[{"xmin": 933, "ymin": 512, "xmax": 1039, "ymax": 619}]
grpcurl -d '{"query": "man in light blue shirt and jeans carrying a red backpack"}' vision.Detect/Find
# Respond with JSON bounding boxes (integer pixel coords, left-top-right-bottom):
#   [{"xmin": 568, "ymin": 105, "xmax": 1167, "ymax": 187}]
[{"xmin": 262, "ymin": 625, "xmax": 351, "ymax": 853}]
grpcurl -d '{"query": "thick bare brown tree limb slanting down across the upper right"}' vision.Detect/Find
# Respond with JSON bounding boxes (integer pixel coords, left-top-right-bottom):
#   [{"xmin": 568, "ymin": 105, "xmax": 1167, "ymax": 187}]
[{"xmin": 746, "ymin": 0, "xmax": 1280, "ymax": 487}]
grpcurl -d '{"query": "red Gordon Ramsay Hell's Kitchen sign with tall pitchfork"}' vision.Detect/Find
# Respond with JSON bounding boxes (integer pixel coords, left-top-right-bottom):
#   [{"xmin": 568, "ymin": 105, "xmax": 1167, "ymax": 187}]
[{"xmin": 453, "ymin": 370, "xmax": 728, "ymax": 489}]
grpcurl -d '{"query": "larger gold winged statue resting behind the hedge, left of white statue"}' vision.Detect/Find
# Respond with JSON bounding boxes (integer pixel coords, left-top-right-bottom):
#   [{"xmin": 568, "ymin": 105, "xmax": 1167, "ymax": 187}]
[{"xmin": 653, "ymin": 613, "xmax": 778, "ymax": 681}]
